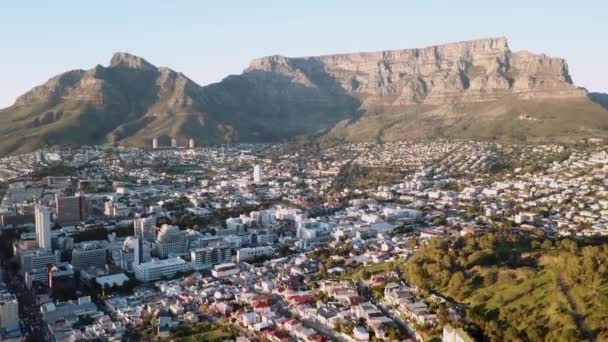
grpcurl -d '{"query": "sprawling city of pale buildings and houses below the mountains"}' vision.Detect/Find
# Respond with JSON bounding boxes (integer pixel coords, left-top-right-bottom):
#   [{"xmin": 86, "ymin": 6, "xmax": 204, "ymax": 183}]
[{"xmin": 0, "ymin": 140, "xmax": 608, "ymax": 341}]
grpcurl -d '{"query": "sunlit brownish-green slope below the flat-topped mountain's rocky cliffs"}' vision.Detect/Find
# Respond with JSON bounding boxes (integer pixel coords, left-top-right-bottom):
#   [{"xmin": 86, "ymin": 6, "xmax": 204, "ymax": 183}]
[{"xmin": 329, "ymin": 98, "xmax": 608, "ymax": 142}]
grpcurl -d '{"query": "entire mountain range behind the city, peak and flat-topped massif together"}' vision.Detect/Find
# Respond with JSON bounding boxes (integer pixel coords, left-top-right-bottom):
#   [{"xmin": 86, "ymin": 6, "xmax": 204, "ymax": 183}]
[{"xmin": 0, "ymin": 38, "xmax": 608, "ymax": 154}]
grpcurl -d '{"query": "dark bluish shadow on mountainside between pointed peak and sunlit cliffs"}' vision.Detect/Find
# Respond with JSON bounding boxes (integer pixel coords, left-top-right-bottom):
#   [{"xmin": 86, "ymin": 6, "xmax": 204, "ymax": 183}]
[{"xmin": 203, "ymin": 60, "xmax": 361, "ymax": 142}]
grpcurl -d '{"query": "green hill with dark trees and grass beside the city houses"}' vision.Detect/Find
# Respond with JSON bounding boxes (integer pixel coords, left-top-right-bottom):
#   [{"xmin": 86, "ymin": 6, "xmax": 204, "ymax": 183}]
[{"xmin": 405, "ymin": 233, "xmax": 608, "ymax": 341}]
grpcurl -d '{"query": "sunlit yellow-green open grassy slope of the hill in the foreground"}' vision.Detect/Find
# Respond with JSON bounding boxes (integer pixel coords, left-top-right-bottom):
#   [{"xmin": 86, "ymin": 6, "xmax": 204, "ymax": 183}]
[{"xmin": 456, "ymin": 252, "xmax": 608, "ymax": 341}]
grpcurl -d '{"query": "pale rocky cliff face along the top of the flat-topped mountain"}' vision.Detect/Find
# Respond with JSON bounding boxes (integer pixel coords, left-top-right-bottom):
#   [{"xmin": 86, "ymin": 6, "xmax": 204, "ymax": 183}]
[{"xmin": 248, "ymin": 38, "xmax": 585, "ymax": 106}]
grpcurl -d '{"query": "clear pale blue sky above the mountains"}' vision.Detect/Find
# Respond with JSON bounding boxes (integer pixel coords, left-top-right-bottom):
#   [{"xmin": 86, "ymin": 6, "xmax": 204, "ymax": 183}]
[{"xmin": 0, "ymin": 0, "xmax": 608, "ymax": 107}]
